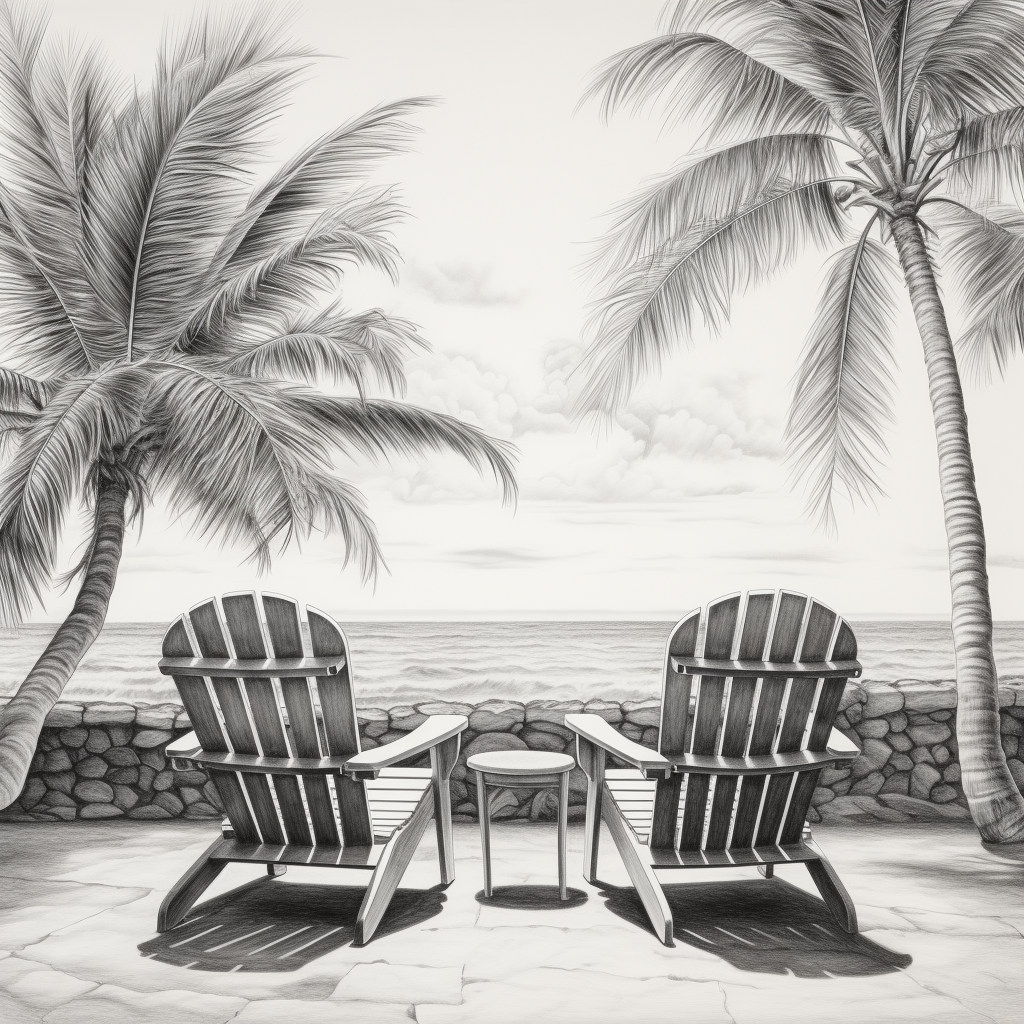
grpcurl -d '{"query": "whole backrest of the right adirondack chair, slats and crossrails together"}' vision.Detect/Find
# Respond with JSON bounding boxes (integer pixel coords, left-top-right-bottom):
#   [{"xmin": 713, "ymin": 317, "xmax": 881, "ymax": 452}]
[{"xmin": 649, "ymin": 590, "xmax": 861, "ymax": 853}]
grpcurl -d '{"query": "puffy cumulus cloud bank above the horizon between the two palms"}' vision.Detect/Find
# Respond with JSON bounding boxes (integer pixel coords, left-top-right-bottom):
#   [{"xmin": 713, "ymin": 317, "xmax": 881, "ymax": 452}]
[{"xmin": 348, "ymin": 341, "xmax": 782, "ymax": 502}]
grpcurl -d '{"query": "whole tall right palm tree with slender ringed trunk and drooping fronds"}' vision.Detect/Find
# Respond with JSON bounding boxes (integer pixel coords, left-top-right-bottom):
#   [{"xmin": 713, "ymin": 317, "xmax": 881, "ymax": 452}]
[{"xmin": 580, "ymin": 0, "xmax": 1024, "ymax": 842}]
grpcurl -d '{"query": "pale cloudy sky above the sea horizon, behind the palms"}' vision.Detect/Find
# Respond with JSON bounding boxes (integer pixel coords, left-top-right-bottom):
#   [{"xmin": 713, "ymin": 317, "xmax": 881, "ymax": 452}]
[{"xmin": 25, "ymin": 0, "xmax": 1024, "ymax": 621}]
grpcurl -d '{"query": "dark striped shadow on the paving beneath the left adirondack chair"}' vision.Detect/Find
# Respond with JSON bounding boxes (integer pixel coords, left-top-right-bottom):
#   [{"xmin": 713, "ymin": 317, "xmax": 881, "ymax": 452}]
[{"xmin": 138, "ymin": 879, "xmax": 447, "ymax": 972}]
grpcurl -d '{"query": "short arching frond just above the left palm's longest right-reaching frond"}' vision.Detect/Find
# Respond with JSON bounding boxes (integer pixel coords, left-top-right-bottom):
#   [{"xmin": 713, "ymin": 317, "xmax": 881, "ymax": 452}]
[{"xmin": 223, "ymin": 306, "xmax": 426, "ymax": 395}]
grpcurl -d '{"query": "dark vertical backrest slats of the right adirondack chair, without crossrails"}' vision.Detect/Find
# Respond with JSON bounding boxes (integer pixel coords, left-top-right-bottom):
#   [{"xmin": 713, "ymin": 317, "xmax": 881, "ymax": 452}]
[{"xmin": 656, "ymin": 590, "xmax": 857, "ymax": 851}]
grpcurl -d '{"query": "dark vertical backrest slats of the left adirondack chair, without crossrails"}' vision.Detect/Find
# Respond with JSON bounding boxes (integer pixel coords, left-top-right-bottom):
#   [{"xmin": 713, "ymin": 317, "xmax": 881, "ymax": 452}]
[{"xmin": 163, "ymin": 591, "xmax": 373, "ymax": 848}]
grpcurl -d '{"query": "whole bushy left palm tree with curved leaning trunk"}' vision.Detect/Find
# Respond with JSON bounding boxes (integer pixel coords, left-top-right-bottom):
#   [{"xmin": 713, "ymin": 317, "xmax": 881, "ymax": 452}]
[{"xmin": 0, "ymin": 2, "xmax": 515, "ymax": 807}]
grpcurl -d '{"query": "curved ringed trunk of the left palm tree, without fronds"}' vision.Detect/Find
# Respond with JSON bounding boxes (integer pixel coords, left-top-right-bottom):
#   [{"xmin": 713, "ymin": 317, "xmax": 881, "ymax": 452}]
[{"xmin": 0, "ymin": 481, "xmax": 128, "ymax": 808}]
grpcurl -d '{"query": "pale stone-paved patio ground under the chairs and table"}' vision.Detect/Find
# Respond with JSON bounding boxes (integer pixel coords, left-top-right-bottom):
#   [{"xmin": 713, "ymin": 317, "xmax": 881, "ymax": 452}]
[{"xmin": 0, "ymin": 822, "xmax": 1024, "ymax": 1024}]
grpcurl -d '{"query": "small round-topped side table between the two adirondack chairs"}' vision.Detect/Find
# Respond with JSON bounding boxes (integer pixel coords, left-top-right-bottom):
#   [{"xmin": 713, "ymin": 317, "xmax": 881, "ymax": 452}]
[{"xmin": 466, "ymin": 751, "xmax": 575, "ymax": 899}]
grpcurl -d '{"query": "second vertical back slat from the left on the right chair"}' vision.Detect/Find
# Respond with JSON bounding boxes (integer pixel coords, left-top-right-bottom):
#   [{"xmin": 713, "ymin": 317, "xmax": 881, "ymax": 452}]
[{"xmin": 679, "ymin": 595, "xmax": 739, "ymax": 850}]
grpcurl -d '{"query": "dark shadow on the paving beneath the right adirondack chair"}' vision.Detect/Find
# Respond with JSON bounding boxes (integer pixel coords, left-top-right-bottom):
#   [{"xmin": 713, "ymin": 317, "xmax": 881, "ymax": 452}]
[{"xmin": 597, "ymin": 878, "xmax": 913, "ymax": 978}]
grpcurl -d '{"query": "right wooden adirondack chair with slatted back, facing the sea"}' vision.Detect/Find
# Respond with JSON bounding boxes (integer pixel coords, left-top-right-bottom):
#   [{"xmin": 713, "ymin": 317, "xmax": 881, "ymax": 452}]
[{"xmin": 565, "ymin": 591, "xmax": 860, "ymax": 945}]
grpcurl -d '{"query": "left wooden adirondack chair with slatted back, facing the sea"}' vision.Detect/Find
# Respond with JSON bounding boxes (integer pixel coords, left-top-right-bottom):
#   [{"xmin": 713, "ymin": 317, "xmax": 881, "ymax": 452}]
[{"xmin": 157, "ymin": 592, "xmax": 468, "ymax": 944}]
